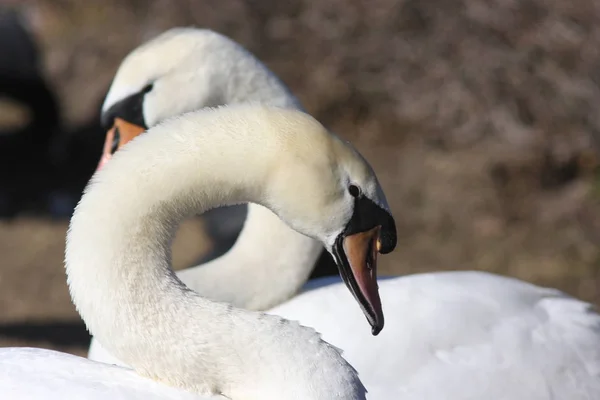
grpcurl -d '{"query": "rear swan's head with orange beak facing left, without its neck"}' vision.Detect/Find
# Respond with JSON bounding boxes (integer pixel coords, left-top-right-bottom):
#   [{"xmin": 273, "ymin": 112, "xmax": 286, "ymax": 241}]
[{"xmin": 98, "ymin": 28, "xmax": 196, "ymax": 169}]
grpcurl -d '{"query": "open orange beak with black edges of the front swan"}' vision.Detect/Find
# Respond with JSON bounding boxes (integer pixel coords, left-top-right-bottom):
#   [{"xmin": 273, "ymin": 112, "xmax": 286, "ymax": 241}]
[{"xmin": 340, "ymin": 225, "xmax": 384, "ymax": 336}]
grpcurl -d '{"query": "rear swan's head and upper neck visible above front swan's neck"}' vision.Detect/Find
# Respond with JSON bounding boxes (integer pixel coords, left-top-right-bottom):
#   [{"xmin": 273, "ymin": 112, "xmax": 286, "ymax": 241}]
[{"xmin": 98, "ymin": 27, "xmax": 300, "ymax": 169}]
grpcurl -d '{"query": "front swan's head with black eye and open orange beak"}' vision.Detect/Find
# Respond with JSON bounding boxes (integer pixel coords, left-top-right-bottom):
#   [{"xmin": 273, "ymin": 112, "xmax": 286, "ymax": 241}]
[{"xmin": 265, "ymin": 111, "xmax": 397, "ymax": 335}]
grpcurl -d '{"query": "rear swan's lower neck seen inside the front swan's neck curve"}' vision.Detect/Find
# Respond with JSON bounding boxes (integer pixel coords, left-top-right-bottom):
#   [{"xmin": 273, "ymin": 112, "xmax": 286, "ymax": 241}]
[{"xmin": 177, "ymin": 203, "xmax": 323, "ymax": 310}]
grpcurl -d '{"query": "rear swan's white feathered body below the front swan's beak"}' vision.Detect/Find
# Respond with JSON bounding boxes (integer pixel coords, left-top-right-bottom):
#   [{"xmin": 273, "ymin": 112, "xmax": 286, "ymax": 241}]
[{"xmin": 269, "ymin": 271, "xmax": 600, "ymax": 400}]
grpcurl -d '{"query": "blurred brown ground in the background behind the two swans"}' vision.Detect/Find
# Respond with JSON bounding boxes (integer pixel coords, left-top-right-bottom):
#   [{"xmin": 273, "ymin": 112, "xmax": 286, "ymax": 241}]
[{"xmin": 0, "ymin": 0, "xmax": 600, "ymax": 354}]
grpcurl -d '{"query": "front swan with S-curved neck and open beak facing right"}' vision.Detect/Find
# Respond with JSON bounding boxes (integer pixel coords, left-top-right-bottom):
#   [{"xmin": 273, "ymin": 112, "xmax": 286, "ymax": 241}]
[{"xmin": 0, "ymin": 105, "xmax": 396, "ymax": 400}]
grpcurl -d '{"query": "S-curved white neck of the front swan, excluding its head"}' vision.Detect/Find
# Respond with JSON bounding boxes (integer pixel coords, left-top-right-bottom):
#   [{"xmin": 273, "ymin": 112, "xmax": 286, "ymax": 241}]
[{"xmin": 66, "ymin": 107, "xmax": 365, "ymax": 400}]
